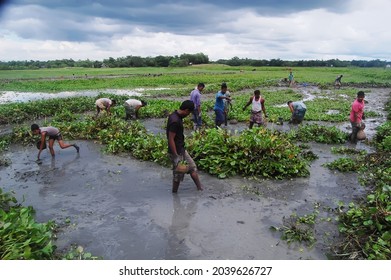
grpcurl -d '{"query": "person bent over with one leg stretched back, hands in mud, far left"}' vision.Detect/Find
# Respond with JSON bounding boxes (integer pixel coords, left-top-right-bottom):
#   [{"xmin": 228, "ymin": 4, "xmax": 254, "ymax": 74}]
[{"xmin": 31, "ymin": 124, "xmax": 79, "ymax": 160}]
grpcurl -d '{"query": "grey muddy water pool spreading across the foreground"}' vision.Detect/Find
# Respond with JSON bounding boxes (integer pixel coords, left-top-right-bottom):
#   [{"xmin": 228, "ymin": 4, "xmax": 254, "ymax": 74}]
[{"xmin": 0, "ymin": 86, "xmax": 384, "ymax": 260}]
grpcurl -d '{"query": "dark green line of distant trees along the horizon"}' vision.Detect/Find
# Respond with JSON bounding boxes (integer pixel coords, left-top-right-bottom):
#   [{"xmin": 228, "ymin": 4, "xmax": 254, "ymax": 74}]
[{"xmin": 0, "ymin": 53, "xmax": 391, "ymax": 70}]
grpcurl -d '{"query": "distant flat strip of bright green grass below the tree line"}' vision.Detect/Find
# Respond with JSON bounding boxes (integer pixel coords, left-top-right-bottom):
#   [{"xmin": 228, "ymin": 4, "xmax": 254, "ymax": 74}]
[{"xmin": 0, "ymin": 64, "xmax": 391, "ymax": 93}]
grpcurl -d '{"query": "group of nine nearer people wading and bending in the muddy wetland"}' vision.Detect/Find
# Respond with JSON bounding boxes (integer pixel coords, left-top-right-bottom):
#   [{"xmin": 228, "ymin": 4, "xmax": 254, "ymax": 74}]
[{"xmin": 31, "ymin": 79, "xmax": 365, "ymax": 193}]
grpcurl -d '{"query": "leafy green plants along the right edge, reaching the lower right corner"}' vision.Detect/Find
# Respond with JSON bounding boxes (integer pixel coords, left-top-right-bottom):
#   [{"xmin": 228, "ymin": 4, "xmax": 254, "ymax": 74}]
[{"xmin": 333, "ymin": 99, "xmax": 391, "ymax": 260}]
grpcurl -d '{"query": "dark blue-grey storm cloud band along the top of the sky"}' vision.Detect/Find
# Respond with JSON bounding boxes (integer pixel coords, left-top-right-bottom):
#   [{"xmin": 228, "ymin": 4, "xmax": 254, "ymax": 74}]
[{"xmin": 3, "ymin": 0, "xmax": 349, "ymax": 41}]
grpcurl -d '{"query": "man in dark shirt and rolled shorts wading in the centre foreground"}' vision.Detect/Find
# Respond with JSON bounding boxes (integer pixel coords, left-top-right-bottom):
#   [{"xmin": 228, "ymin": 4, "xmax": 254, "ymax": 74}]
[{"xmin": 166, "ymin": 100, "xmax": 203, "ymax": 193}]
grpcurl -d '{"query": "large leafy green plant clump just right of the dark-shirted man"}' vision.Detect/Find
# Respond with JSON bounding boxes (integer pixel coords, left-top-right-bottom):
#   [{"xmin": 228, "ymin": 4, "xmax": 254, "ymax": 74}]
[{"xmin": 189, "ymin": 128, "xmax": 309, "ymax": 179}]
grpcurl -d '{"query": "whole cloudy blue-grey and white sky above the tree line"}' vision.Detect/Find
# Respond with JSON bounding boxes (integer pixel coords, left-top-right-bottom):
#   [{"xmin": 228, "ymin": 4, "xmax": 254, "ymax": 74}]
[{"xmin": 0, "ymin": 0, "xmax": 391, "ymax": 61}]
